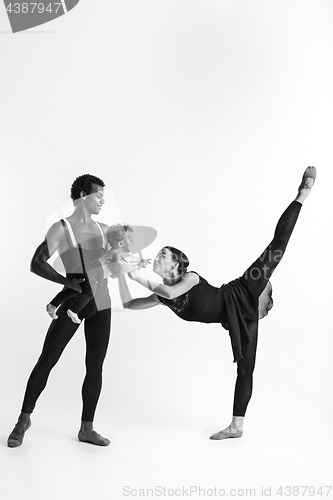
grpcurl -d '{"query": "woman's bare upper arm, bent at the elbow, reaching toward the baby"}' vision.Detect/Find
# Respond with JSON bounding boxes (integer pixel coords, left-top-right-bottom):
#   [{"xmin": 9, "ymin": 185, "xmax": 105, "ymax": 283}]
[{"xmin": 128, "ymin": 273, "xmax": 199, "ymax": 299}]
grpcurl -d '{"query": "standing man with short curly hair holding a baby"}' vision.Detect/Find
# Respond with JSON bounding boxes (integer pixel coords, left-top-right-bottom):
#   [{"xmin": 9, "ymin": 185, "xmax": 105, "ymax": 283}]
[{"xmin": 7, "ymin": 174, "xmax": 111, "ymax": 448}]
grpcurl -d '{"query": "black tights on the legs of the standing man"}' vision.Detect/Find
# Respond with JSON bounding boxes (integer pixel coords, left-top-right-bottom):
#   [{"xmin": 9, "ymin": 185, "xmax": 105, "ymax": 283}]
[{"xmin": 22, "ymin": 294, "xmax": 111, "ymax": 422}]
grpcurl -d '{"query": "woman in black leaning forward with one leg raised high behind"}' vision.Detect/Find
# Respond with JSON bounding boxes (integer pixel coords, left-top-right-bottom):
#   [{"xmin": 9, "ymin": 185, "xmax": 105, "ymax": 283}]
[{"xmin": 119, "ymin": 167, "xmax": 317, "ymax": 439}]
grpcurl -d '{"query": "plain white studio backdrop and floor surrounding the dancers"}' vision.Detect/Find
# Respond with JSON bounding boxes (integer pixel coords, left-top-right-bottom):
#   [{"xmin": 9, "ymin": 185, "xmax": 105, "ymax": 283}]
[{"xmin": 0, "ymin": 0, "xmax": 333, "ymax": 500}]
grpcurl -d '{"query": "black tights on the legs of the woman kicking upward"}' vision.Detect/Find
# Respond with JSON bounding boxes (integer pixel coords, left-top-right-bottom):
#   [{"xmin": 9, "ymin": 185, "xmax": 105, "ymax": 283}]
[{"xmin": 233, "ymin": 201, "xmax": 302, "ymax": 417}]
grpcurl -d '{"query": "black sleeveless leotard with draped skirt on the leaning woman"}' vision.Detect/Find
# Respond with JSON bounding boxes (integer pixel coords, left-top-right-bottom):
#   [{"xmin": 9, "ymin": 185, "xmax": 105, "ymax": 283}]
[{"xmin": 158, "ymin": 271, "xmax": 258, "ymax": 362}]
